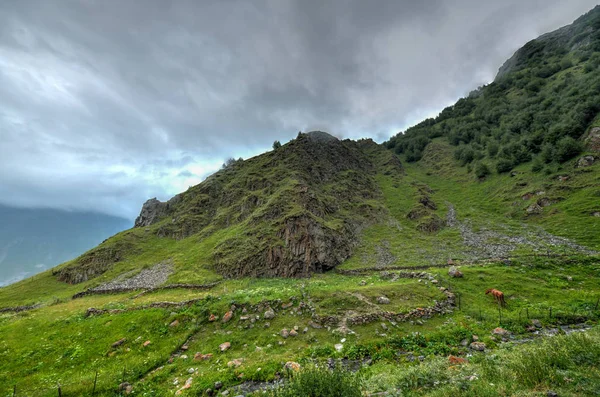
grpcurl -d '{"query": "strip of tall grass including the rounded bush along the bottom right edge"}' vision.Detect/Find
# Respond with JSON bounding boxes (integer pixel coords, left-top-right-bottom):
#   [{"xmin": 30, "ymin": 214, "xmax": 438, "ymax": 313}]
[{"xmin": 270, "ymin": 329, "xmax": 600, "ymax": 397}]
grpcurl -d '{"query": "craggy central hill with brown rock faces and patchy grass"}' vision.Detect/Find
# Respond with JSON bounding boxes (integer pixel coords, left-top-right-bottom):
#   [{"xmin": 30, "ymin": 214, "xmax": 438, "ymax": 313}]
[{"xmin": 57, "ymin": 131, "xmax": 402, "ymax": 283}]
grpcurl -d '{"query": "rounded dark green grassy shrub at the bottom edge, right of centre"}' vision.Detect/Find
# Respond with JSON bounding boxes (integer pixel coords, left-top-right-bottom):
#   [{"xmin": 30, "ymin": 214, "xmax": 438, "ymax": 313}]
[{"xmin": 270, "ymin": 368, "xmax": 362, "ymax": 397}]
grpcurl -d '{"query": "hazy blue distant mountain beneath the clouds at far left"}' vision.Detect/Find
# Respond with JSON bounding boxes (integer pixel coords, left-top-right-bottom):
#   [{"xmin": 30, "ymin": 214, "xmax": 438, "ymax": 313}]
[{"xmin": 0, "ymin": 205, "xmax": 130, "ymax": 286}]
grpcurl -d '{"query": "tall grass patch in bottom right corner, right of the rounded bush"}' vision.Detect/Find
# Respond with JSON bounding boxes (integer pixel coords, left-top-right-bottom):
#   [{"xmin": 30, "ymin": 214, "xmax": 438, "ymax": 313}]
[{"xmin": 396, "ymin": 330, "xmax": 600, "ymax": 397}]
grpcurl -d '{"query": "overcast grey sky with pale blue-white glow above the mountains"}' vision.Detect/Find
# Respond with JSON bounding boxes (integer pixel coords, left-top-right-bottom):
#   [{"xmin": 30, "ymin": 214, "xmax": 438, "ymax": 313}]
[{"xmin": 0, "ymin": 0, "xmax": 596, "ymax": 218}]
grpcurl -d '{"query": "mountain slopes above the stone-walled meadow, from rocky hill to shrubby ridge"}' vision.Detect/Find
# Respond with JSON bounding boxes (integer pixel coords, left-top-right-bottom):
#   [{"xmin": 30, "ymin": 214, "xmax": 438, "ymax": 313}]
[{"xmin": 21, "ymin": 7, "xmax": 600, "ymax": 286}]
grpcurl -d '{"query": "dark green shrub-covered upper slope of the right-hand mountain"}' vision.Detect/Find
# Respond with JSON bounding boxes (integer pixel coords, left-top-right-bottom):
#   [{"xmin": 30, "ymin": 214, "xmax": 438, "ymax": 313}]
[{"xmin": 385, "ymin": 7, "xmax": 600, "ymax": 177}]
